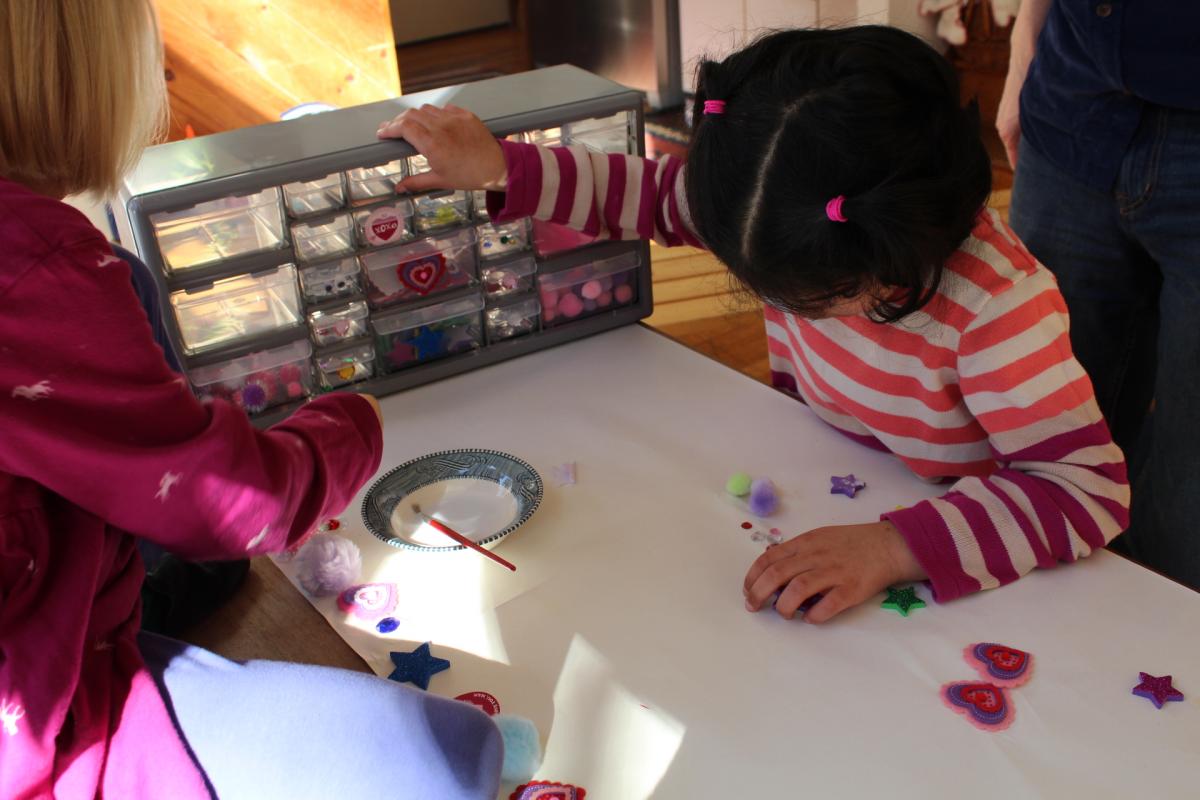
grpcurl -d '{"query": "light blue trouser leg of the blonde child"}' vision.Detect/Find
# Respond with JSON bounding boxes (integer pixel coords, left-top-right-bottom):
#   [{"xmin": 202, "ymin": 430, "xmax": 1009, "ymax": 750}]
[{"xmin": 138, "ymin": 632, "xmax": 504, "ymax": 800}]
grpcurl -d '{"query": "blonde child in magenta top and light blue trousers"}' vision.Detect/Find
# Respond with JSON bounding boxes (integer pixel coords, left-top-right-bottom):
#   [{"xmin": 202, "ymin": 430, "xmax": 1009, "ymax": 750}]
[{"xmin": 0, "ymin": 0, "xmax": 502, "ymax": 800}]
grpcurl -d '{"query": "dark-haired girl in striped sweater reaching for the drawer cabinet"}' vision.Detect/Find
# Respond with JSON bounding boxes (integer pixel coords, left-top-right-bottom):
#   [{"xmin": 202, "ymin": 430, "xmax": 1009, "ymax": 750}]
[{"xmin": 379, "ymin": 26, "xmax": 1129, "ymax": 622}]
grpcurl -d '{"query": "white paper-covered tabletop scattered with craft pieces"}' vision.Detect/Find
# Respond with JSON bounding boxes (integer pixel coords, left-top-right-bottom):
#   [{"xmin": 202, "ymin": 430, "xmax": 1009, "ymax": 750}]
[{"xmin": 276, "ymin": 326, "xmax": 1200, "ymax": 800}]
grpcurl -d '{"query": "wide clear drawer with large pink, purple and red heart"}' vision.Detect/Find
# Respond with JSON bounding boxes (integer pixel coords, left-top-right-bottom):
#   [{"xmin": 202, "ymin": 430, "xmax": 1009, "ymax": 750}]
[{"xmin": 359, "ymin": 228, "xmax": 476, "ymax": 308}]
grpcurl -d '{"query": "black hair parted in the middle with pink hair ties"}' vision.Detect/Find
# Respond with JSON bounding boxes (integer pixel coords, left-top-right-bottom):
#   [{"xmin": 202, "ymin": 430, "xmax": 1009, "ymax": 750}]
[{"xmin": 686, "ymin": 25, "xmax": 991, "ymax": 321}]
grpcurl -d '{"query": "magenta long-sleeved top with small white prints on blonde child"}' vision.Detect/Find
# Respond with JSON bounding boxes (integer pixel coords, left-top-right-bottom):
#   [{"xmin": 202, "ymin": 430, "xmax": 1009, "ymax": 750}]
[{"xmin": 0, "ymin": 180, "xmax": 383, "ymax": 800}]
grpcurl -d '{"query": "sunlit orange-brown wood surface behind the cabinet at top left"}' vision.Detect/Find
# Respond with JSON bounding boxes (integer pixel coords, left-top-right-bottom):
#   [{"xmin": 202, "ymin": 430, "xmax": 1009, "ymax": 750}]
[{"xmin": 155, "ymin": 0, "xmax": 400, "ymax": 139}]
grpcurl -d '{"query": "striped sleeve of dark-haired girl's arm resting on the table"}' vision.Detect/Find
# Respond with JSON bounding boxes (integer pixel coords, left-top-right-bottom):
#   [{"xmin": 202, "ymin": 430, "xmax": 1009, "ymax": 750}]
[{"xmin": 883, "ymin": 270, "xmax": 1129, "ymax": 601}]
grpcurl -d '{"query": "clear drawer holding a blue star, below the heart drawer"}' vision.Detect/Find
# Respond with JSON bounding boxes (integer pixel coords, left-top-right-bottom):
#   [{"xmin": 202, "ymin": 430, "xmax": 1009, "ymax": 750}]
[{"xmin": 371, "ymin": 294, "xmax": 484, "ymax": 373}]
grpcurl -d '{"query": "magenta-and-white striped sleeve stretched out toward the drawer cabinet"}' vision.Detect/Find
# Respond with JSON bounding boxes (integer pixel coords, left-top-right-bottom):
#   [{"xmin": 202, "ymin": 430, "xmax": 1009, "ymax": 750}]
[{"xmin": 487, "ymin": 140, "xmax": 703, "ymax": 247}]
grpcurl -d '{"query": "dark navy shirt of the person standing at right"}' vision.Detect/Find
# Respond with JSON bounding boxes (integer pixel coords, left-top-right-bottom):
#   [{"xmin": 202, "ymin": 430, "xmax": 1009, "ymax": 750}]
[{"xmin": 1021, "ymin": 0, "xmax": 1200, "ymax": 191}]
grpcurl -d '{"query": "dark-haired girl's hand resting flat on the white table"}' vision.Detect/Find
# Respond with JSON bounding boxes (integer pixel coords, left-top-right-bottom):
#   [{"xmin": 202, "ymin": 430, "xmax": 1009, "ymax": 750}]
[{"xmin": 743, "ymin": 522, "xmax": 928, "ymax": 622}]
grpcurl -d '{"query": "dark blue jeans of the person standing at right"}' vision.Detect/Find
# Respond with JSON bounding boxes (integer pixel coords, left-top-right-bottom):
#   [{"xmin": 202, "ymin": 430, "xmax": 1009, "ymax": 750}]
[{"xmin": 1010, "ymin": 108, "xmax": 1200, "ymax": 589}]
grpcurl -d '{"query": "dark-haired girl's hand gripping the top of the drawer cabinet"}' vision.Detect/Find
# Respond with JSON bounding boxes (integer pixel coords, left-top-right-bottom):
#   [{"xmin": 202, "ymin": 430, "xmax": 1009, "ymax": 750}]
[{"xmin": 377, "ymin": 104, "xmax": 508, "ymax": 192}]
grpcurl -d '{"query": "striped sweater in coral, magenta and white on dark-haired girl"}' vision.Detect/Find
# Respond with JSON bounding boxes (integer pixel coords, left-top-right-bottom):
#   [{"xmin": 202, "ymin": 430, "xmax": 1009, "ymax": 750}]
[{"xmin": 488, "ymin": 142, "xmax": 1129, "ymax": 601}]
